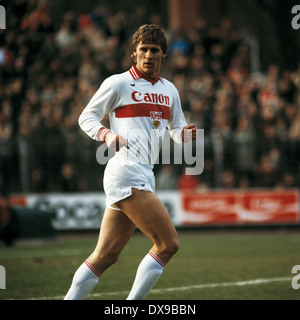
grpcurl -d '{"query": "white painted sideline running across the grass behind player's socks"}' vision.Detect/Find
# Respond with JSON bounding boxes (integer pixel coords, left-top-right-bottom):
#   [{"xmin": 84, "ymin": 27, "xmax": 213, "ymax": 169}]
[{"xmin": 27, "ymin": 277, "xmax": 292, "ymax": 300}]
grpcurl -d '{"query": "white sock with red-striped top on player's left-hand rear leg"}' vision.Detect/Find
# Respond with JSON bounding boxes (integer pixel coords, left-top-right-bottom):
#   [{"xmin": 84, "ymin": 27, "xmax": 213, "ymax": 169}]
[{"xmin": 64, "ymin": 260, "xmax": 101, "ymax": 300}]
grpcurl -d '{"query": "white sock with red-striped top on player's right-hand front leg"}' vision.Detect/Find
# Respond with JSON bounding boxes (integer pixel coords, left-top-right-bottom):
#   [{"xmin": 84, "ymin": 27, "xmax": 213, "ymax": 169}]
[{"xmin": 127, "ymin": 250, "xmax": 166, "ymax": 300}]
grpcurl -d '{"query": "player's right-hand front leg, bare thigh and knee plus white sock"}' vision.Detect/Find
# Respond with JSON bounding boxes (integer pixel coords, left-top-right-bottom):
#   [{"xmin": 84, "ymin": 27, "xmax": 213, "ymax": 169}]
[{"xmin": 117, "ymin": 189, "xmax": 179, "ymax": 300}]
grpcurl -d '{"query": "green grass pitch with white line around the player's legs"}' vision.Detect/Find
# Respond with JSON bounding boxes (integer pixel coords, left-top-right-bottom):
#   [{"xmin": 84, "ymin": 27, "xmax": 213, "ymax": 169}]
[{"xmin": 0, "ymin": 229, "xmax": 300, "ymax": 300}]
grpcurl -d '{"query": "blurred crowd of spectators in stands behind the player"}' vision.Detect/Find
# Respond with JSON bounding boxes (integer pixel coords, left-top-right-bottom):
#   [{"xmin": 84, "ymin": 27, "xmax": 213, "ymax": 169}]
[{"xmin": 0, "ymin": 0, "xmax": 300, "ymax": 192}]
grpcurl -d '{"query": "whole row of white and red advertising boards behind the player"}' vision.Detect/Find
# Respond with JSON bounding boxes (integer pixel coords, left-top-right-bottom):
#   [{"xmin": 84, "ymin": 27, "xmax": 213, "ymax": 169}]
[{"xmin": 10, "ymin": 189, "xmax": 300, "ymax": 230}]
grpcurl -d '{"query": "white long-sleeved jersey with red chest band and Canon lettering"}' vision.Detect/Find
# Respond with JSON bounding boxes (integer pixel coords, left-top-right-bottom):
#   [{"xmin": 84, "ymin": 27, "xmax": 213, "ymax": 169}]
[{"xmin": 79, "ymin": 66, "xmax": 187, "ymax": 165}]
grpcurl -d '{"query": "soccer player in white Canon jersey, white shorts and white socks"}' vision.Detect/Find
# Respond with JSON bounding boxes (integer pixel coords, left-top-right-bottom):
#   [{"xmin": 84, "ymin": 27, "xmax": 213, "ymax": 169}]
[{"xmin": 65, "ymin": 25, "xmax": 196, "ymax": 300}]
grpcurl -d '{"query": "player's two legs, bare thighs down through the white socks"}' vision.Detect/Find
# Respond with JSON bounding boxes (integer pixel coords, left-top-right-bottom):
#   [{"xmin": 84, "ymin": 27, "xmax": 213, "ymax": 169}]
[{"xmin": 66, "ymin": 189, "xmax": 179, "ymax": 299}]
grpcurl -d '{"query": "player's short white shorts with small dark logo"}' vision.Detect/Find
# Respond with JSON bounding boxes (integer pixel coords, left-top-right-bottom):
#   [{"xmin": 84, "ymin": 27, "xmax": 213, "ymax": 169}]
[{"xmin": 103, "ymin": 155, "xmax": 155, "ymax": 210}]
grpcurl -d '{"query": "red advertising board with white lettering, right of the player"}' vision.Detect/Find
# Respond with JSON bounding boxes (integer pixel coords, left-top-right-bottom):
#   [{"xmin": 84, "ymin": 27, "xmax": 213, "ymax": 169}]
[{"xmin": 181, "ymin": 190, "xmax": 299, "ymax": 226}]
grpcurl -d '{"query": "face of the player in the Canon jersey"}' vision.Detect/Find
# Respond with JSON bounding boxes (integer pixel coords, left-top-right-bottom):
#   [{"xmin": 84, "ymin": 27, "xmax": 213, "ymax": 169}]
[{"xmin": 134, "ymin": 42, "xmax": 165, "ymax": 80}]
